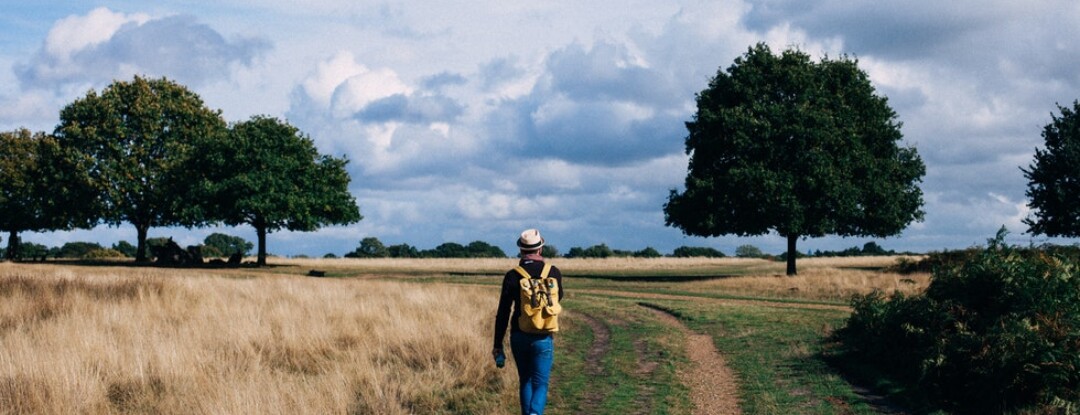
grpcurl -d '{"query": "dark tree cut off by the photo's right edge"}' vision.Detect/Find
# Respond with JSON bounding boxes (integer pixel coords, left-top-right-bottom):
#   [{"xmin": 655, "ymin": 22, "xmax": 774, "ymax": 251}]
[{"xmin": 1022, "ymin": 102, "xmax": 1080, "ymax": 237}]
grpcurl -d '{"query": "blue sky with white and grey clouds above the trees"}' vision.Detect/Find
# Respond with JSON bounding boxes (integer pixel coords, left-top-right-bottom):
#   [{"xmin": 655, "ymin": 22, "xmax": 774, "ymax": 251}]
[{"xmin": 0, "ymin": 0, "xmax": 1080, "ymax": 256}]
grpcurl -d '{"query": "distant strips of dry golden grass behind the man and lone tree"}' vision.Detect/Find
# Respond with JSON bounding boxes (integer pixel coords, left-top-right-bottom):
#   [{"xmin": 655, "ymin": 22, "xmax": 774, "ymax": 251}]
[{"xmin": 273, "ymin": 256, "xmax": 930, "ymax": 302}]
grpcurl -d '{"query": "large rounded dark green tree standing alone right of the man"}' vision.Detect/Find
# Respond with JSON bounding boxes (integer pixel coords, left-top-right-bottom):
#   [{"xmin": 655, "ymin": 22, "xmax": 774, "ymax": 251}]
[{"xmin": 664, "ymin": 44, "xmax": 926, "ymax": 276}]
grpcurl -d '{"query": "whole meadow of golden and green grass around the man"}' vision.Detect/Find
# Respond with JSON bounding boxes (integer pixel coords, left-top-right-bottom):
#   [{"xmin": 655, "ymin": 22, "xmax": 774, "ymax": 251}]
[{"xmin": 0, "ymin": 257, "xmax": 929, "ymax": 414}]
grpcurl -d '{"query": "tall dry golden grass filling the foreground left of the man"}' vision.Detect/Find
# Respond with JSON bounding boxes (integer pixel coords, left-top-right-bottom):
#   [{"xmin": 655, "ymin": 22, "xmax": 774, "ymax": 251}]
[{"xmin": 0, "ymin": 264, "xmax": 515, "ymax": 414}]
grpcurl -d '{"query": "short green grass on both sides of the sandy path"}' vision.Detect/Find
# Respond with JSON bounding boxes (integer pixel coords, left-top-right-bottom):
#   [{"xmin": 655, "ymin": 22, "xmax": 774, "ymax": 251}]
[{"xmin": 549, "ymin": 295, "xmax": 907, "ymax": 414}]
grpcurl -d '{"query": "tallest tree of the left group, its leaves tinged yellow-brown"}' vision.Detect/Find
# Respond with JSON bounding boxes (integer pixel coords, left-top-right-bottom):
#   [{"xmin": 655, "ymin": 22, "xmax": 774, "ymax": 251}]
[{"xmin": 55, "ymin": 77, "xmax": 226, "ymax": 262}]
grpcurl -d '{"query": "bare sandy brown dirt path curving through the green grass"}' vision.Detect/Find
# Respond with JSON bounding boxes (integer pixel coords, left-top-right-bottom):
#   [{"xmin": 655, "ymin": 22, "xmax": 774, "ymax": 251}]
[{"xmin": 649, "ymin": 308, "xmax": 742, "ymax": 415}]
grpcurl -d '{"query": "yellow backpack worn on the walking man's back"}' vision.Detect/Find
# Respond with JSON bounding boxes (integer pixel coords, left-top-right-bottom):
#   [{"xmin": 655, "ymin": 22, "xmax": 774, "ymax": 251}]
[{"xmin": 514, "ymin": 264, "xmax": 563, "ymax": 334}]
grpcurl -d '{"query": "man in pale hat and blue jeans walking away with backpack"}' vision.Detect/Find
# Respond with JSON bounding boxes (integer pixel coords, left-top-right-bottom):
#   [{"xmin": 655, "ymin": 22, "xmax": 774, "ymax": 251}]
[{"xmin": 491, "ymin": 229, "xmax": 565, "ymax": 415}]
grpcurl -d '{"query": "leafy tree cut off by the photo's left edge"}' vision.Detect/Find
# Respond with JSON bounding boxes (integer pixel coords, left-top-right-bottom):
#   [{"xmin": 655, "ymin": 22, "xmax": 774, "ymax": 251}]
[{"xmin": 0, "ymin": 129, "xmax": 96, "ymax": 259}]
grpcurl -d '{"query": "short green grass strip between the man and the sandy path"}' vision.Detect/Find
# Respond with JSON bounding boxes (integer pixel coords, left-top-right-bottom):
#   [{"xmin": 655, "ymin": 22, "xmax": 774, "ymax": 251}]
[{"xmin": 548, "ymin": 296, "xmax": 691, "ymax": 415}]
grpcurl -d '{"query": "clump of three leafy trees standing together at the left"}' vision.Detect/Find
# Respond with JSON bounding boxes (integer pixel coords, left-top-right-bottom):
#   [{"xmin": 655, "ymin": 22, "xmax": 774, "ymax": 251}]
[{"xmin": 0, "ymin": 77, "xmax": 362, "ymax": 265}]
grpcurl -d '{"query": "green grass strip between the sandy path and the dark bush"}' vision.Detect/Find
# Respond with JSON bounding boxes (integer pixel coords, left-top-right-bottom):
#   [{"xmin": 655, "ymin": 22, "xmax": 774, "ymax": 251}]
[{"xmin": 651, "ymin": 300, "xmax": 898, "ymax": 414}]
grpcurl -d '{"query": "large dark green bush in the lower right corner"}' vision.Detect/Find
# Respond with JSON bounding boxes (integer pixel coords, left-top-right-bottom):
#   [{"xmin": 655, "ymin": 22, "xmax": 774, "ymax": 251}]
[{"xmin": 837, "ymin": 229, "xmax": 1080, "ymax": 414}]
